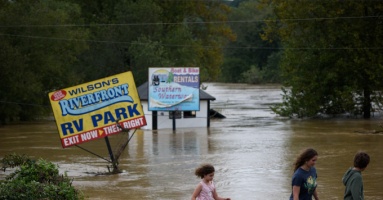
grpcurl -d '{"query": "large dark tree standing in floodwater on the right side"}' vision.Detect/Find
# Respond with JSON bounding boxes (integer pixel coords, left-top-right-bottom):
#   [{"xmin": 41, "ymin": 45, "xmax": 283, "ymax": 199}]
[{"xmin": 263, "ymin": 0, "xmax": 383, "ymax": 118}]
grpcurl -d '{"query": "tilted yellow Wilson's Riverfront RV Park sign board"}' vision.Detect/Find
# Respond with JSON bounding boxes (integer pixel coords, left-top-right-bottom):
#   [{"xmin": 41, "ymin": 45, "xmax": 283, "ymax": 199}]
[{"xmin": 49, "ymin": 72, "xmax": 146, "ymax": 148}]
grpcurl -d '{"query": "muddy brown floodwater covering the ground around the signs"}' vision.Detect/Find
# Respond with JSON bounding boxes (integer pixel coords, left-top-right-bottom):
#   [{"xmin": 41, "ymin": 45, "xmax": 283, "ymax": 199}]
[{"xmin": 0, "ymin": 83, "xmax": 383, "ymax": 200}]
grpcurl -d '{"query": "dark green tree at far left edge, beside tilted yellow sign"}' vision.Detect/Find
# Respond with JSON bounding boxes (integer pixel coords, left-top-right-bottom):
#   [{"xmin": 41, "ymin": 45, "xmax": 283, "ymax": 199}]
[{"xmin": 0, "ymin": 0, "xmax": 87, "ymax": 123}]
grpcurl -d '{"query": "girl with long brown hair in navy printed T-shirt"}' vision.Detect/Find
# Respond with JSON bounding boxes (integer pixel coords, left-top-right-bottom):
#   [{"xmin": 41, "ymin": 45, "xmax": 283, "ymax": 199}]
[{"xmin": 290, "ymin": 148, "xmax": 319, "ymax": 200}]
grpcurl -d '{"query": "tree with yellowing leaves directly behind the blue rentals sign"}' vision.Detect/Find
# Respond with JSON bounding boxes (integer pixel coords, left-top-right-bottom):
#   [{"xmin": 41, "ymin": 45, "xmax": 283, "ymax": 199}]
[{"xmin": 157, "ymin": 1, "xmax": 235, "ymax": 81}]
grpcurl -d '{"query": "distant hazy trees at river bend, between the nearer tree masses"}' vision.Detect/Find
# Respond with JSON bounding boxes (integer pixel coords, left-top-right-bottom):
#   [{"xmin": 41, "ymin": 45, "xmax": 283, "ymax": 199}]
[{"xmin": 221, "ymin": 0, "xmax": 280, "ymax": 83}]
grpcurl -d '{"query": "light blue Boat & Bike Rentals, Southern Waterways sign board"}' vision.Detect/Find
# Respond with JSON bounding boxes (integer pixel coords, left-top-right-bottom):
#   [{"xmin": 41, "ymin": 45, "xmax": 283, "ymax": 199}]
[{"xmin": 148, "ymin": 67, "xmax": 200, "ymax": 111}]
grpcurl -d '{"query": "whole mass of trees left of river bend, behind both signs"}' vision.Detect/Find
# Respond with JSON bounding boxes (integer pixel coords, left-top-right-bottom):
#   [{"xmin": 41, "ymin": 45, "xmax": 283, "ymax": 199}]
[{"xmin": 0, "ymin": 0, "xmax": 235, "ymax": 123}]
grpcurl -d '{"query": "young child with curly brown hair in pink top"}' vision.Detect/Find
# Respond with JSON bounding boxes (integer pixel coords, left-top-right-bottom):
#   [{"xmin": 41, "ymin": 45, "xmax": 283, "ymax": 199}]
[{"xmin": 192, "ymin": 164, "xmax": 230, "ymax": 200}]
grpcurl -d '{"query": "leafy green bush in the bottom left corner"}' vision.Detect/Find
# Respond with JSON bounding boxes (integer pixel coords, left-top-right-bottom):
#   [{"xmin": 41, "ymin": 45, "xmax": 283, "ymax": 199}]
[{"xmin": 0, "ymin": 154, "xmax": 84, "ymax": 200}]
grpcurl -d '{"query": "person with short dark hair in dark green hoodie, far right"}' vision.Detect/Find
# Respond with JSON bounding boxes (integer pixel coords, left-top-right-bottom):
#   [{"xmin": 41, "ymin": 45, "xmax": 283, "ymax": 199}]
[{"xmin": 342, "ymin": 152, "xmax": 370, "ymax": 200}]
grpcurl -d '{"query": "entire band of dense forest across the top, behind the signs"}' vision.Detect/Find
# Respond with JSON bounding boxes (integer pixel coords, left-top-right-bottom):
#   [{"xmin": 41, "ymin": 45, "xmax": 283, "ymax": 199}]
[{"xmin": 0, "ymin": 0, "xmax": 383, "ymax": 123}]
